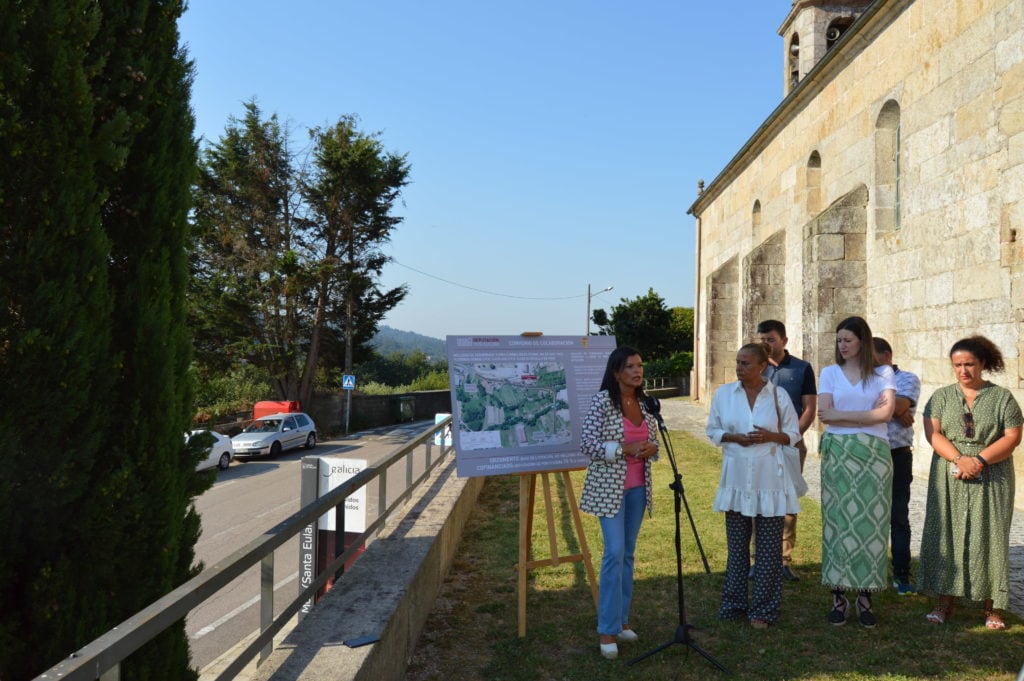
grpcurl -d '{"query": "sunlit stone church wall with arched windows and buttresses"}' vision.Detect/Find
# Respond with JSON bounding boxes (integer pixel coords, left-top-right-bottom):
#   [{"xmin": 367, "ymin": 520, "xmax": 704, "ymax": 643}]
[{"xmin": 691, "ymin": 0, "xmax": 1024, "ymax": 493}]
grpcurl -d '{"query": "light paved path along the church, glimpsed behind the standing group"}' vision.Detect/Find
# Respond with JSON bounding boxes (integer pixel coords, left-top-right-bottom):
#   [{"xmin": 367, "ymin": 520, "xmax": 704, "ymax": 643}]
[{"xmin": 662, "ymin": 397, "xmax": 1024, "ymax": 618}]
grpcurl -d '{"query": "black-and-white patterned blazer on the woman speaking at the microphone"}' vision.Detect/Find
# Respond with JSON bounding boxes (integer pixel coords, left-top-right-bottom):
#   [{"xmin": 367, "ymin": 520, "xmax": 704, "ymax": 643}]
[{"xmin": 580, "ymin": 390, "xmax": 657, "ymax": 517}]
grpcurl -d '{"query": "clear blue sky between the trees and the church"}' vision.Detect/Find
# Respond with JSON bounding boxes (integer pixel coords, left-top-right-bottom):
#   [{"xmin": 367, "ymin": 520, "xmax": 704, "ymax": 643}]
[{"xmin": 180, "ymin": 0, "xmax": 791, "ymax": 338}]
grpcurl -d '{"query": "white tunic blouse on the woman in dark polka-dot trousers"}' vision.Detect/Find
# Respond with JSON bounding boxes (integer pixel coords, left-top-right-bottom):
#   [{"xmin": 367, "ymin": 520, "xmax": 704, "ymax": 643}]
[{"xmin": 706, "ymin": 381, "xmax": 801, "ymax": 517}]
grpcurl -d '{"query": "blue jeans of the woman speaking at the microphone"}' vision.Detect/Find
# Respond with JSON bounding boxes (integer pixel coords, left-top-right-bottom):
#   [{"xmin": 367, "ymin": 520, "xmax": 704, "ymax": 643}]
[{"xmin": 597, "ymin": 485, "xmax": 647, "ymax": 636}]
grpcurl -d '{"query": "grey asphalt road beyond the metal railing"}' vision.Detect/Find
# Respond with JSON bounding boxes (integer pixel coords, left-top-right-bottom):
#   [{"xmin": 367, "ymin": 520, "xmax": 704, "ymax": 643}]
[{"xmin": 185, "ymin": 421, "xmax": 433, "ymax": 669}]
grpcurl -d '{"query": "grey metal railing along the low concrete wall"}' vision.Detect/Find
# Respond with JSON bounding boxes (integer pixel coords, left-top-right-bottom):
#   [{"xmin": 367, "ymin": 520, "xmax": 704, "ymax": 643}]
[{"xmin": 36, "ymin": 417, "xmax": 454, "ymax": 681}]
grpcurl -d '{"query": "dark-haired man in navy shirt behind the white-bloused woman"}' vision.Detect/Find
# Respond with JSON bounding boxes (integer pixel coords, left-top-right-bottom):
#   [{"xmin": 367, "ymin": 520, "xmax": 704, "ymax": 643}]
[{"xmin": 758, "ymin": 320, "xmax": 818, "ymax": 582}]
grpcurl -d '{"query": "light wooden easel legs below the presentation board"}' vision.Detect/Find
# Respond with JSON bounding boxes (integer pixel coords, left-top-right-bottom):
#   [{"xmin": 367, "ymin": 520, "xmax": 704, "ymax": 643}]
[{"xmin": 516, "ymin": 470, "xmax": 597, "ymax": 638}]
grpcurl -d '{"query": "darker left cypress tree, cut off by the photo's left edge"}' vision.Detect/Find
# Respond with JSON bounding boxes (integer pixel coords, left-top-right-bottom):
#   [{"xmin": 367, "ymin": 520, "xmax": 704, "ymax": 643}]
[{"xmin": 0, "ymin": 0, "xmax": 113, "ymax": 679}]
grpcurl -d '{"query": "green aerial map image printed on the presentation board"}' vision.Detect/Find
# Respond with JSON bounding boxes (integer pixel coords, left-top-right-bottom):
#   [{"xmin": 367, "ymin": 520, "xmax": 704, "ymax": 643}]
[{"xmin": 450, "ymin": 360, "xmax": 572, "ymax": 451}]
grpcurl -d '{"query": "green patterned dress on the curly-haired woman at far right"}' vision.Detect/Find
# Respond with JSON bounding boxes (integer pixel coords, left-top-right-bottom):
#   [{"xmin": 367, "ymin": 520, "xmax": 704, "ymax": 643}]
[{"xmin": 920, "ymin": 383, "xmax": 1024, "ymax": 609}]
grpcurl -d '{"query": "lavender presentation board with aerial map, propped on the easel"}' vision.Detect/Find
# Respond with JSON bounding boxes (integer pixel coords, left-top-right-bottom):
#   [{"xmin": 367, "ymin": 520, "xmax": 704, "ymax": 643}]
[{"xmin": 446, "ymin": 336, "xmax": 615, "ymax": 477}]
